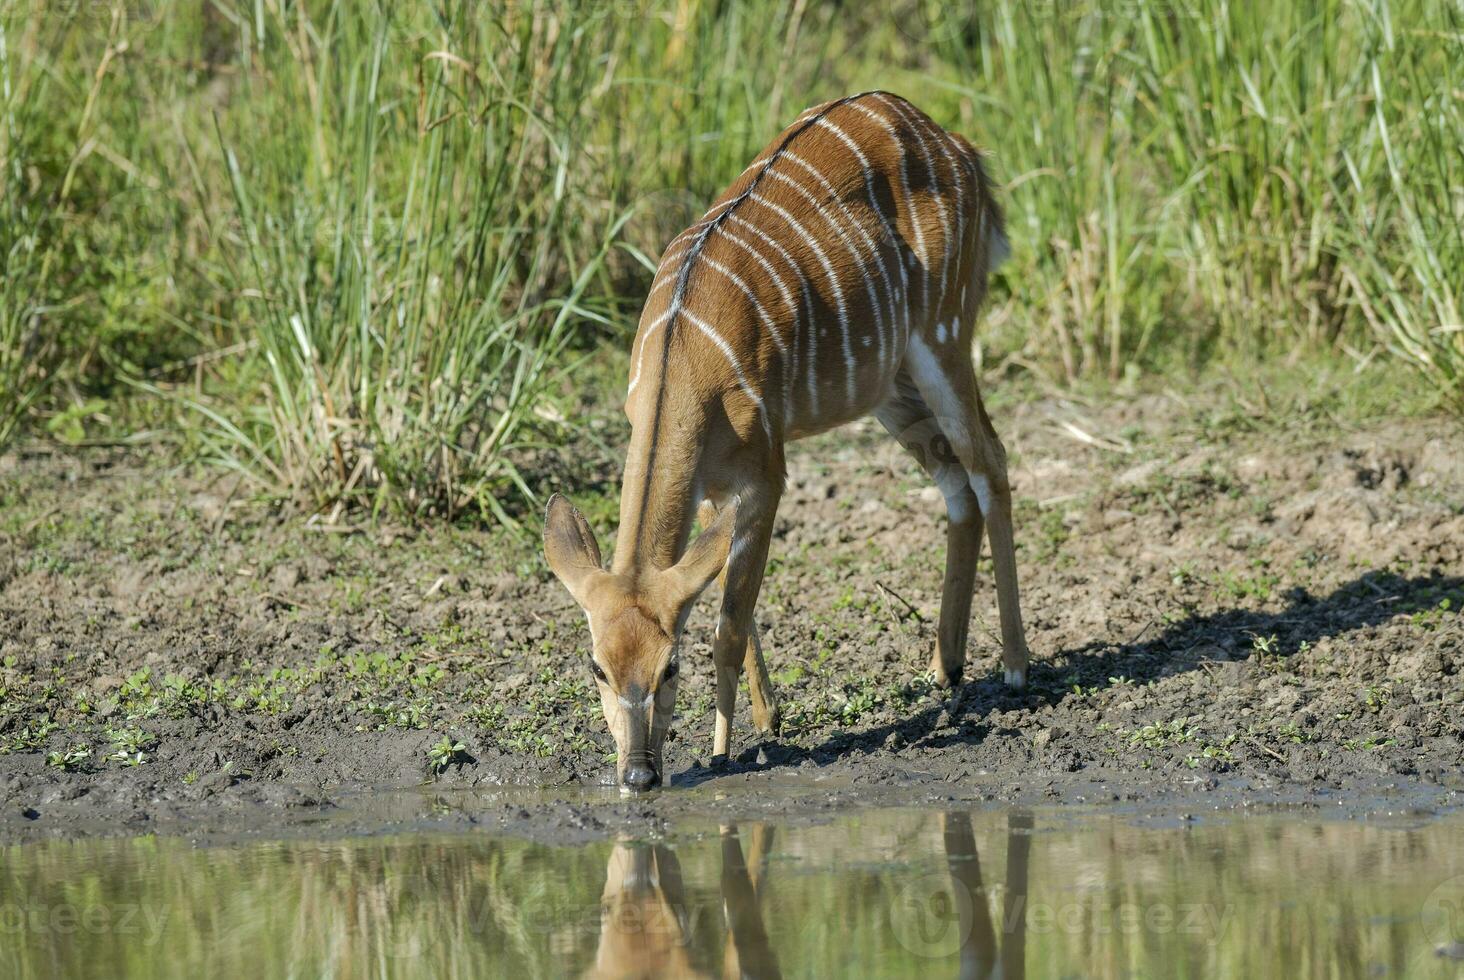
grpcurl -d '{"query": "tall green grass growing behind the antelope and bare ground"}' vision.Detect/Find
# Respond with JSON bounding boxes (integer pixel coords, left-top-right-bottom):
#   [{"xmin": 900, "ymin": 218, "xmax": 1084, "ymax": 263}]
[{"xmin": 0, "ymin": 0, "xmax": 1464, "ymax": 521}]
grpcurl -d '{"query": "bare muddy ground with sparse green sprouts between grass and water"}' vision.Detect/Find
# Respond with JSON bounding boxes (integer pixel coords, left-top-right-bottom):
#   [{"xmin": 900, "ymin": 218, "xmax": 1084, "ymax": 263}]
[{"xmin": 0, "ymin": 375, "xmax": 1464, "ymax": 839}]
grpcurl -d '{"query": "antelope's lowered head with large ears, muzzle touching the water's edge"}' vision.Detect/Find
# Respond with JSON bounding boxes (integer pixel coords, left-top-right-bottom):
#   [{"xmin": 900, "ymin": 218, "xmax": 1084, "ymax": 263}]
[{"xmin": 545, "ymin": 494, "xmax": 736, "ymax": 792}]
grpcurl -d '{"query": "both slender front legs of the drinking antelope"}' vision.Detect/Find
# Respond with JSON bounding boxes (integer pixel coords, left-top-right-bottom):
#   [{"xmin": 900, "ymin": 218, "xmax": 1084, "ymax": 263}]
[{"xmin": 712, "ymin": 486, "xmax": 779, "ymax": 763}]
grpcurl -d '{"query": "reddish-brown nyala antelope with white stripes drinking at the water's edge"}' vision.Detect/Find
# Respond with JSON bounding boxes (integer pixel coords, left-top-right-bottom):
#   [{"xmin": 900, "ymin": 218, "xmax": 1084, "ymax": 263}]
[{"xmin": 545, "ymin": 92, "xmax": 1028, "ymax": 791}]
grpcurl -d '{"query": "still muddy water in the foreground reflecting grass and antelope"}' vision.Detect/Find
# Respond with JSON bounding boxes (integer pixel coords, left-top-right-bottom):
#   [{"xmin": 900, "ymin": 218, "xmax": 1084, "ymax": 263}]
[{"xmin": 0, "ymin": 810, "xmax": 1464, "ymax": 977}]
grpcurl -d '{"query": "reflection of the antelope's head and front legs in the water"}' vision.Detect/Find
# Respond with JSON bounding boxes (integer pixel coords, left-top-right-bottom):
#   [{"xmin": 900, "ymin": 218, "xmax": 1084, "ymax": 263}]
[{"xmin": 586, "ymin": 823, "xmax": 782, "ymax": 979}]
